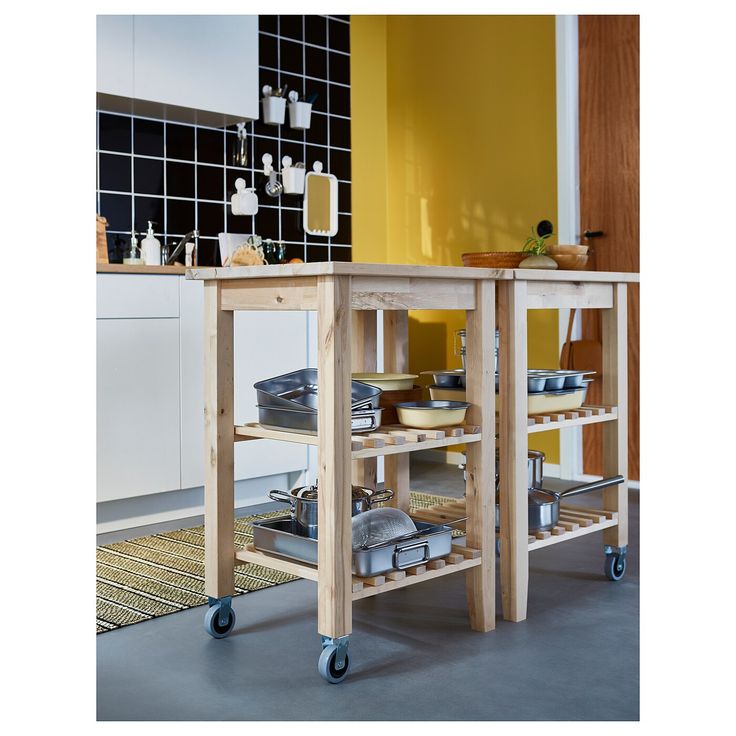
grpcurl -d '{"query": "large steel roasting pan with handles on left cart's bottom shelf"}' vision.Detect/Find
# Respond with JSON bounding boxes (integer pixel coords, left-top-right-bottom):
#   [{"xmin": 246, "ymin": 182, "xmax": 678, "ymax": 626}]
[{"xmin": 253, "ymin": 516, "xmax": 452, "ymax": 577}]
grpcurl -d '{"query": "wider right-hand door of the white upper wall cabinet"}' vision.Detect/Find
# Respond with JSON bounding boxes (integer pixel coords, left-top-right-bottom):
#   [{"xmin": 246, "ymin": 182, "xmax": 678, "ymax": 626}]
[{"xmin": 134, "ymin": 15, "xmax": 258, "ymax": 124}]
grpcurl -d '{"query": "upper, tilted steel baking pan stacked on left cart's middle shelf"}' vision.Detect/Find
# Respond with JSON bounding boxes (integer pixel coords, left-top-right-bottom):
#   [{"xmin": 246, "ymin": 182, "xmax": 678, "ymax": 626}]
[{"xmin": 253, "ymin": 368, "xmax": 381, "ymax": 412}]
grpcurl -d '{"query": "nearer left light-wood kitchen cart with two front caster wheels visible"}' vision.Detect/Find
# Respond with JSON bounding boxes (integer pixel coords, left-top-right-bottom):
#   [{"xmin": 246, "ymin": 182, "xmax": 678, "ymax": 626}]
[{"xmin": 187, "ymin": 262, "xmax": 504, "ymax": 682}]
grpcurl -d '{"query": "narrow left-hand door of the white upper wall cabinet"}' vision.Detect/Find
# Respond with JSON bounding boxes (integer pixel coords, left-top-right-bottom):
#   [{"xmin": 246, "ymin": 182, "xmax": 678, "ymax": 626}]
[{"xmin": 97, "ymin": 15, "xmax": 134, "ymax": 97}]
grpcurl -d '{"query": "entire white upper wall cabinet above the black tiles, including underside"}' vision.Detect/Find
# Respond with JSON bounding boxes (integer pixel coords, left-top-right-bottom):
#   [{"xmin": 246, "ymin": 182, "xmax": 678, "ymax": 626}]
[{"xmin": 97, "ymin": 15, "xmax": 259, "ymax": 127}]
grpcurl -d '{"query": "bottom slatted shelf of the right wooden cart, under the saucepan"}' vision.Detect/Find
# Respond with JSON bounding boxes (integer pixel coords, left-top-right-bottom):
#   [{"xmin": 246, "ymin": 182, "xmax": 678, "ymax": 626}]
[{"xmin": 410, "ymin": 498, "xmax": 618, "ymax": 552}]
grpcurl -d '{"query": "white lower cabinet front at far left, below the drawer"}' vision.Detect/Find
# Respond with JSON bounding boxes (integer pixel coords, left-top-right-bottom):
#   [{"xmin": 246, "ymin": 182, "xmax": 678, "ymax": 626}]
[{"xmin": 97, "ymin": 316, "xmax": 181, "ymax": 501}]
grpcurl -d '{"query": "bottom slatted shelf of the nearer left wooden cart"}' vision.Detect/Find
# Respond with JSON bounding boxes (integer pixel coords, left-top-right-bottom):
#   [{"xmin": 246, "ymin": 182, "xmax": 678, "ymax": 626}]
[{"xmin": 235, "ymin": 544, "xmax": 482, "ymax": 601}]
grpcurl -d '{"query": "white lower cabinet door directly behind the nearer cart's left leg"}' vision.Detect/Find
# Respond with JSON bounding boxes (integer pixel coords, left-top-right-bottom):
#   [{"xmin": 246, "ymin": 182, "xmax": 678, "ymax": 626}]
[{"xmin": 180, "ymin": 280, "xmax": 307, "ymax": 492}]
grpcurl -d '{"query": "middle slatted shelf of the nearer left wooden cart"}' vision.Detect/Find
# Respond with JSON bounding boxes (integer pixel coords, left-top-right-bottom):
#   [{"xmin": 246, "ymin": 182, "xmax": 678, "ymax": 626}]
[{"xmin": 235, "ymin": 422, "xmax": 482, "ymax": 460}]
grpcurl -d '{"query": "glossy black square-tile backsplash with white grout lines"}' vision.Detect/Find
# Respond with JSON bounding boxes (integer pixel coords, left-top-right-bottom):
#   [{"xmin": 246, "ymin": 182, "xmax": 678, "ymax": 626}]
[{"xmin": 97, "ymin": 15, "xmax": 352, "ymax": 265}]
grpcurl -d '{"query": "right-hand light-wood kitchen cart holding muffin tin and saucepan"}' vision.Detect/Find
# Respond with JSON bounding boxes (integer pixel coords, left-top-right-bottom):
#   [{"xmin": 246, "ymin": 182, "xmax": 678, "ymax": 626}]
[{"xmin": 414, "ymin": 269, "xmax": 639, "ymax": 621}]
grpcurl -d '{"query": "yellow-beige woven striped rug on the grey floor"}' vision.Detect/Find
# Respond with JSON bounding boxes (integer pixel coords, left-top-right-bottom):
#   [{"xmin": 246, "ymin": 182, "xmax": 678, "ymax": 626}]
[{"xmin": 97, "ymin": 492, "xmax": 458, "ymax": 634}]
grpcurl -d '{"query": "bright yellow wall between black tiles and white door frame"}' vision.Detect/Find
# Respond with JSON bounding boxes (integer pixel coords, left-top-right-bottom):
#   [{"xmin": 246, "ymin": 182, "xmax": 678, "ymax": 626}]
[{"xmin": 351, "ymin": 15, "xmax": 559, "ymax": 463}]
